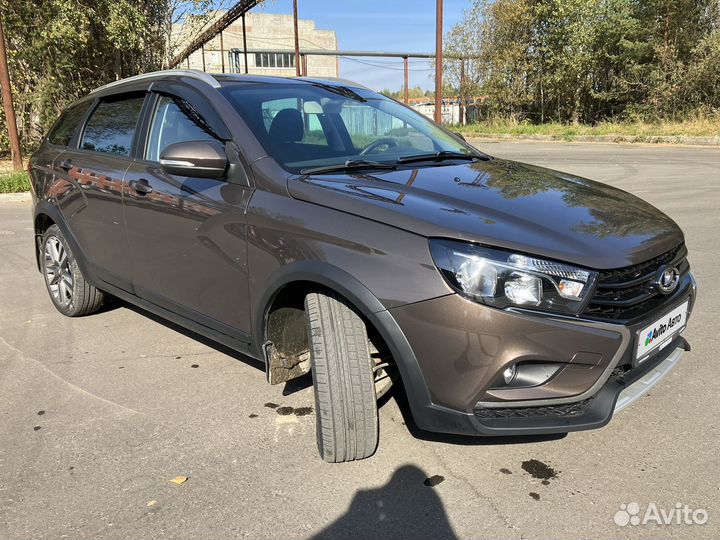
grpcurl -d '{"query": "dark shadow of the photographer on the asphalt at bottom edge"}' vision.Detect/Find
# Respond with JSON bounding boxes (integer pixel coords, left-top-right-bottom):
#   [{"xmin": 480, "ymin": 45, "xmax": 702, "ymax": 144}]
[{"xmin": 311, "ymin": 465, "xmax": 457, "ymax": 540}]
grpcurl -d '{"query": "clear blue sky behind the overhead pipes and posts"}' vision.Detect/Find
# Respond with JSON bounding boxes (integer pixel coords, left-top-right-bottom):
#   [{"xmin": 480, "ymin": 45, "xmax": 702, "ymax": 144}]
[{"xmin": 253, "ymin": 0, "xmax": 471, "ymax": 90}]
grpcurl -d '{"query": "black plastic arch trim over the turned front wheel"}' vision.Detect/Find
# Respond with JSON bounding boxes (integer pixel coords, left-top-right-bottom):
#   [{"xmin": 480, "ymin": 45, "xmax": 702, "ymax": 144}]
[{"xmin": 253, "ymin": 261, "xmax": 436, "ymax": 429}]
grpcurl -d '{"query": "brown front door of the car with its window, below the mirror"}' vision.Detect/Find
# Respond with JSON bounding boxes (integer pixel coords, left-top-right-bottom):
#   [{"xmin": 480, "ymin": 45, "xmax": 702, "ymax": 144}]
[{"xmin": 124, "ymin": 95, "xmax": 251, "ymax": 337}]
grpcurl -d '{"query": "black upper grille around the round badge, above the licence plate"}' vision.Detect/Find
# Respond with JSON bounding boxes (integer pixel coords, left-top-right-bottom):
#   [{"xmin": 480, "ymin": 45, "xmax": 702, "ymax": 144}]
[{"xmin": 584, "ymin": 244, "xmax": 690, "ymax": 320}]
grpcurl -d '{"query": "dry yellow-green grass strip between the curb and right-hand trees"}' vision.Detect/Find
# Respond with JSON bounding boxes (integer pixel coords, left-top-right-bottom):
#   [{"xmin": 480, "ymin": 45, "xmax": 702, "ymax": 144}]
[{"xmin": 454, "ymin": 118, "xmax": 720, "ymax": 143}]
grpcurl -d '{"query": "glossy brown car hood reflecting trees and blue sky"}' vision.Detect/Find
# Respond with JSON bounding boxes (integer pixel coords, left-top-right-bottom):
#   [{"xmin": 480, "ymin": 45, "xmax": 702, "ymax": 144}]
[{"xmin": 288, "ymin": 159, "xmax": 683, "ymax": 269}]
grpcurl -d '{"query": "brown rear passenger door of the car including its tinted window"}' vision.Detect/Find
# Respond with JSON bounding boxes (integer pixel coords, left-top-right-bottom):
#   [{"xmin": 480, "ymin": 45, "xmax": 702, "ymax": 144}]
[{"xmin": 55, "ymin": 92, "xmax": 145, "ymax": 290}]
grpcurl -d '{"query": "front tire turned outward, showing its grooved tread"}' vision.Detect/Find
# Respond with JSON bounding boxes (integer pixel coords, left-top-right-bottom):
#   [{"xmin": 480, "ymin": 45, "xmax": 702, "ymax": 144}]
[{"xmin": 305, "ymin": 291, "xmax": 378, "ymax": 463}]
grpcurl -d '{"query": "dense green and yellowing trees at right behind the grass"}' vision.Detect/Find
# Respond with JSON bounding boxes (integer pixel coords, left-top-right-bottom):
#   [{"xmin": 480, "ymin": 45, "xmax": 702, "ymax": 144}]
[{"xmin": 444, "ymin": 0, "xmax": 720, "ymax": 123}]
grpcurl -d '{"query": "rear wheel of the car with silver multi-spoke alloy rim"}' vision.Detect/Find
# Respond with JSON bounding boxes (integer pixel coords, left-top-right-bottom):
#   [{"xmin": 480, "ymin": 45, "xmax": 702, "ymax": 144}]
[{"xmin": 40, "ymin": 225, "xmax": 104, "ymax": 317}]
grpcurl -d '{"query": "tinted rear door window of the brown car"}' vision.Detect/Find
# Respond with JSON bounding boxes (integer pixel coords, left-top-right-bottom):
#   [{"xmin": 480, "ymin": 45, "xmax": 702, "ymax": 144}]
[{"xmin": 80, "ymin": 96, "xmax": 145, "ymax": 156}]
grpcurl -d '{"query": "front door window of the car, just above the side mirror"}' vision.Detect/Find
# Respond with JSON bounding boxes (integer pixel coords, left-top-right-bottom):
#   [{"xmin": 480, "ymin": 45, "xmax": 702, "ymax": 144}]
[{"xmin": 145, "ymin": 96, "xmax": 215, "ymax": 162}]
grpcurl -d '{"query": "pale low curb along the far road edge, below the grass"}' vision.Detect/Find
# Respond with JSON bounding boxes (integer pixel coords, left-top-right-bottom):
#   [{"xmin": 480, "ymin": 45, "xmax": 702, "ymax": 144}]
[{"xmin": 463, "ymin": 133, "xmax": 720, "ymax": 147}]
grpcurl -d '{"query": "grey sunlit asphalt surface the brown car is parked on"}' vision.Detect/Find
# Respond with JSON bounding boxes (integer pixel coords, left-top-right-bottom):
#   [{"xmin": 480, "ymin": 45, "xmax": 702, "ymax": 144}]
[{"xmin": 0, "ymin": 142, "xmax": 720, "ymax": 539}]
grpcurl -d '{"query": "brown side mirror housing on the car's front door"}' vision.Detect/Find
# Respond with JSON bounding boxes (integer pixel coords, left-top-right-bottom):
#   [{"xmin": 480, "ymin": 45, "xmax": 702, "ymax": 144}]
[{"xmin": 160, "ymin": 141, "xmax": 228, "ymax": 178}]
